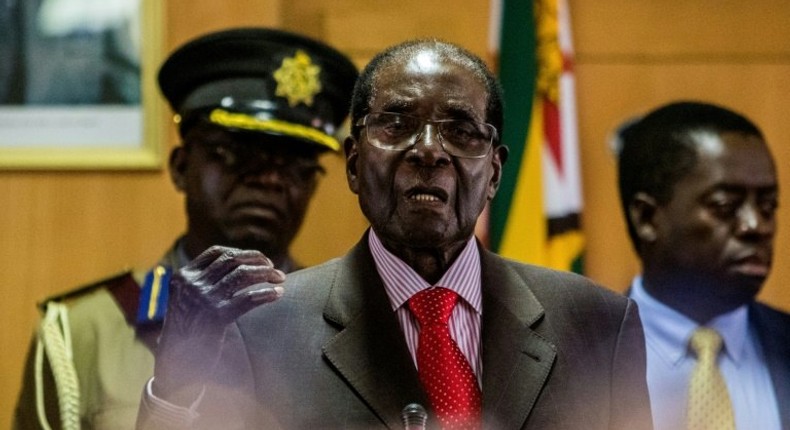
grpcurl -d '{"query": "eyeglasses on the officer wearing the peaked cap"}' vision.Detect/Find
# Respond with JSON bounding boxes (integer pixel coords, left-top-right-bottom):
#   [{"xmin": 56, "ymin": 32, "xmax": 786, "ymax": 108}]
[{"xmin": 200, "ymin": 142, "xmax": 325, "ymax": 182}]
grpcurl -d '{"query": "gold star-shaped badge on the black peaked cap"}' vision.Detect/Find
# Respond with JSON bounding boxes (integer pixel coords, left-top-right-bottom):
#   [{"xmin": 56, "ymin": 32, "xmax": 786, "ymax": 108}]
[{"xmin": 274, "ymin": 49, "xmax": 321, "ymax": 107}]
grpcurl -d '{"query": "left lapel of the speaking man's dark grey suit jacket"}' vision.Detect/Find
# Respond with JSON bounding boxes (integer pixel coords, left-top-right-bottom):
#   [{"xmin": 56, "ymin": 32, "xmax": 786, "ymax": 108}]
[{"xmin": 323, "ymin": 235, "xmax": 428, "ymax": 428}]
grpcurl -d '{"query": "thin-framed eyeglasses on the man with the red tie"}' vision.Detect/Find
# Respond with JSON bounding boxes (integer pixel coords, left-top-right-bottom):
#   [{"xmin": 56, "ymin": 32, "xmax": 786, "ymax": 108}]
[{"xmin": 356, "ymin": 112, "xmax": 497, "ymax": 158}]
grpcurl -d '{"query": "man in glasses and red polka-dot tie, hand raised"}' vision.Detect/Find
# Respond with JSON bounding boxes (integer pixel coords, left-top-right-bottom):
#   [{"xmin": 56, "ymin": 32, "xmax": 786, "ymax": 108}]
[{"xmin": 138, "ymin": 40, "xmax": 651, "ymax": 429}]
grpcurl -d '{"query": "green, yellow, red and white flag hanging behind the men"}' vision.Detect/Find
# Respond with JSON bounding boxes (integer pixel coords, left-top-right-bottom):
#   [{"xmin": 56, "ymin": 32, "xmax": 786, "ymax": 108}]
[{"xmin": 488, "ymin": 0, "xmax": 584, "ymax": 273}]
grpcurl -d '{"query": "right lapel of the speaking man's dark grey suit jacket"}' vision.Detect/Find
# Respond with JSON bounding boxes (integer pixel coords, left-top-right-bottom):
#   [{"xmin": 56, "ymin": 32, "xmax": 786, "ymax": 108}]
[{"xmin": 481, "ymin": 251, "xmax": 556, "ymax": 428}]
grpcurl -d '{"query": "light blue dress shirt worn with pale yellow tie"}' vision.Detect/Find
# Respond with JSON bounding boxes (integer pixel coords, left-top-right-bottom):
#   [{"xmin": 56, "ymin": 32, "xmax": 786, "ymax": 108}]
[{"xmin": 630, "ymin": 277, "xmax": 781, "ymax": 430}]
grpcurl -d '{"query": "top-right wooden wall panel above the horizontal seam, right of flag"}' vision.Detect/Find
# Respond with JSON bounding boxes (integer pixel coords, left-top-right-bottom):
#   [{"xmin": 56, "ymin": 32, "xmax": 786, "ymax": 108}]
[{"xmin": 570, "ymin": 0, "xmax": 790, "ymax": 57}]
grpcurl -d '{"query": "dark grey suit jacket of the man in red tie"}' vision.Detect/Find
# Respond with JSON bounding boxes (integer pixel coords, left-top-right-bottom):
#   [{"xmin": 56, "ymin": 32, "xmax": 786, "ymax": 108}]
[{"xmin": 139, "ymin": 238, "xmax": 652, "ymax": 430}]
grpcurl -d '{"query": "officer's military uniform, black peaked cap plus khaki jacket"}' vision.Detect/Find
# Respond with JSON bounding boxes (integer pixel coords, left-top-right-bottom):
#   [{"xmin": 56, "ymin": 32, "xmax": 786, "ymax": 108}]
[{"xmin": 14, "ymin": 28, "xmax": 358, "ymax": 430}]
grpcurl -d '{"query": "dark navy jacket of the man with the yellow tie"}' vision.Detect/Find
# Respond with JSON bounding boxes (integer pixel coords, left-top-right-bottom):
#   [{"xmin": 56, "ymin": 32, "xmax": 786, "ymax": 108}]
[{"xmin": 749, "ymin": 302, "xmax": 790, "ymax": 429}]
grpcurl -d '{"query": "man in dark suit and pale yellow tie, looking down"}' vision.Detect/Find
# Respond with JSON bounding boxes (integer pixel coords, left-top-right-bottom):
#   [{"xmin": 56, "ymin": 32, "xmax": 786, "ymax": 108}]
[{"xmin": 619, "ymin": 102, "xmax": 790, "ymax": 430}]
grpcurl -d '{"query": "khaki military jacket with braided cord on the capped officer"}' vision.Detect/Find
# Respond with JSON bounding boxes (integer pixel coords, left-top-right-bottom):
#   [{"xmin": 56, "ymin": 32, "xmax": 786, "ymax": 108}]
[{"xmin": 14, "ymin": 245, "xmax": 184, "ymax": 429}]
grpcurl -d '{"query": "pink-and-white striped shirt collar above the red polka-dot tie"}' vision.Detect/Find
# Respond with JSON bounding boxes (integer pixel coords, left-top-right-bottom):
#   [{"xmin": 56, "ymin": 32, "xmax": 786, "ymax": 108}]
[{"xmin": 368, "ymin": 228, "xmax": 482, "ymax": 313}]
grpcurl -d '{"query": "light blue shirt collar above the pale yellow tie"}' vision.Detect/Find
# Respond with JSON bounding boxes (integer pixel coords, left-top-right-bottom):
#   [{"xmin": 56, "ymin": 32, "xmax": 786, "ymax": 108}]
[{"xmin": 630, "ymin": 276, "xmax": 749, "ymax": 366}]
